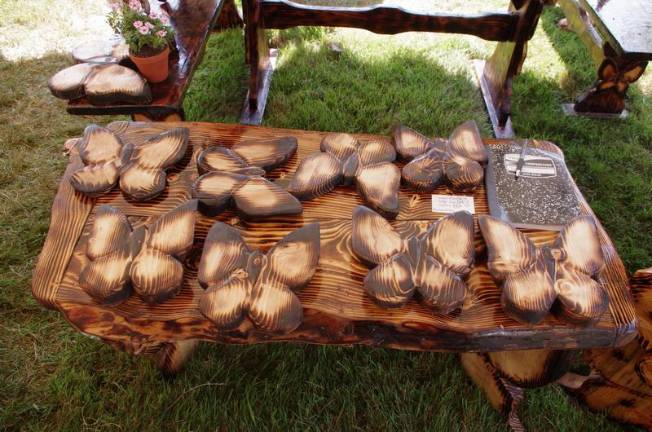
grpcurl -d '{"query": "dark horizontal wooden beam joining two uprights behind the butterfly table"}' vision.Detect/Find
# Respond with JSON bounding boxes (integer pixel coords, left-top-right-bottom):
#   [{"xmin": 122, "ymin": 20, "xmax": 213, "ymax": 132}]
[{"xmin": 260, "ymin": 0, "xmax": 517, "ymax": 41}]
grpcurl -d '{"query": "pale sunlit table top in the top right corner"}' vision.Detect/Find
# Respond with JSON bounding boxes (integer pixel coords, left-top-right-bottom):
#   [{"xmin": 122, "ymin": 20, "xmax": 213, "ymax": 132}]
[{"xmin": 581, "ymin": 0, "xmax": 652, "ymax": 59}]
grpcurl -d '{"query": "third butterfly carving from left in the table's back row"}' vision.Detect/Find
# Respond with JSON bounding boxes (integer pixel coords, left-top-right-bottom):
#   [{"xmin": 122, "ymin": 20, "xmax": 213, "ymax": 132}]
[{"xmin": 288, "ymin": 133, "xmax": 401, "ymax": 218}]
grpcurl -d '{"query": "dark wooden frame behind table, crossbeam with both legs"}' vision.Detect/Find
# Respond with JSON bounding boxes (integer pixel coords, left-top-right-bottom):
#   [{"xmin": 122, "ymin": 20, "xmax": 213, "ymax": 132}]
[{"xmin": 240, "ymin": 0, "xmax": 546, "ymax": 137}]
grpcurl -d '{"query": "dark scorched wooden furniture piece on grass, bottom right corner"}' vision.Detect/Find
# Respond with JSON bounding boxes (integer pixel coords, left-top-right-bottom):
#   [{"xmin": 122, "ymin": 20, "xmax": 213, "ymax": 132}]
[{"xmin": 559, "ymin": 268, "xmax": 652, "ymax": 430}]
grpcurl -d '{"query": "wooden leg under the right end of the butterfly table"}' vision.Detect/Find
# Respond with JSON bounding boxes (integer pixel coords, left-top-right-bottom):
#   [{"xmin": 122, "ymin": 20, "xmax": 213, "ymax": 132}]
[{"xmin": 461, "ymin": 350, "xmax": 569, "ymax": 431}]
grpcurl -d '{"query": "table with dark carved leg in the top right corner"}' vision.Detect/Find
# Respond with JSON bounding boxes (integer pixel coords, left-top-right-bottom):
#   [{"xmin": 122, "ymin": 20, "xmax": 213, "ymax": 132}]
[{"xmin": 557, "ymin": 0, "xmax": 652, "ymax": 117}]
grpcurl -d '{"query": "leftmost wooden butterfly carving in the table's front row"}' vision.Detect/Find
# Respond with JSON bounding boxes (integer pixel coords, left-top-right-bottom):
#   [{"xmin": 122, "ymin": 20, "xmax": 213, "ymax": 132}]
[{"xmin": 79, "ymin": 200, "xmax": 197, "ymax": 303}]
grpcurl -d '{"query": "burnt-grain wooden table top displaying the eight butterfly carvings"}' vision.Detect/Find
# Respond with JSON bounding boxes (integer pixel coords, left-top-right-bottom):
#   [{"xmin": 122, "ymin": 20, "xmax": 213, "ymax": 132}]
[{"xmin": 32, "ymin": 122, "xmax": 636, "ymax": 353}]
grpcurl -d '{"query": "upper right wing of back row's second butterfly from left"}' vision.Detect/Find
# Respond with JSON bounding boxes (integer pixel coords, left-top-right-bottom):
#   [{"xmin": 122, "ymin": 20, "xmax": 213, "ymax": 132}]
[{"xmin": 232, "ymin": 136, "xmax": 297, "ymax": 171}]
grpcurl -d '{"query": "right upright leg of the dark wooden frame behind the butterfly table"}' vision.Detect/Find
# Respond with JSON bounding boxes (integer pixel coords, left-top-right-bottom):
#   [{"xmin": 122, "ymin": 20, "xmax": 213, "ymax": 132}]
[{"xmin": 476, "ymin": 0, "xmax": 542, "ymax": 138}]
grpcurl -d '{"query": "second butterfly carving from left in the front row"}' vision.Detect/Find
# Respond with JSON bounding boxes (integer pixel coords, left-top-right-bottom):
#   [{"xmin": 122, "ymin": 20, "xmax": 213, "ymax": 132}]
[{"xmin": 197, "ymin": 222, "xmax": 320, "ymax": 333}]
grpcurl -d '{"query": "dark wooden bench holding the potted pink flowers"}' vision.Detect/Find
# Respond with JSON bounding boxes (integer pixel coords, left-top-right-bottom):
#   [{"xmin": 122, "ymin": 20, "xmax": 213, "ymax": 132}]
[{"xmin": 67, "ymin": 0, "xmax": 224, "ymax": 116}]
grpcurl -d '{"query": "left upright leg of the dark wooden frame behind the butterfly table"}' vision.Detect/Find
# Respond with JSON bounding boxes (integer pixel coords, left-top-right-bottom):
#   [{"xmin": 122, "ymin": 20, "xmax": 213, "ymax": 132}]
[{"xmin": 240, "ymin": 0, "xmax": 276, "ymax": 125}]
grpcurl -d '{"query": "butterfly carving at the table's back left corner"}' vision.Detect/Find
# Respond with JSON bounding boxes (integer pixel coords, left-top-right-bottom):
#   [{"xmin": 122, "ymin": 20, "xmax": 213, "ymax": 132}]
[{"xmin": 70, "ymin": 125, "xmax": 188, "ymax": 201}]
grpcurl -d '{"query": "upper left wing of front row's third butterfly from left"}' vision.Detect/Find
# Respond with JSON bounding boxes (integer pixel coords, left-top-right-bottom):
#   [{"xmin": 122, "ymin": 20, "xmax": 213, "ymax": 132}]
[{"xmin": 351, "ymin": 206, "xmax": 402, "ymax": 265}]
